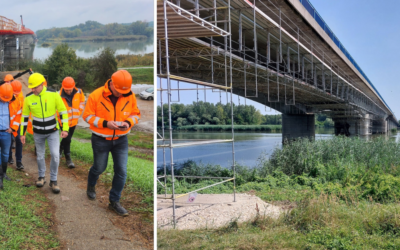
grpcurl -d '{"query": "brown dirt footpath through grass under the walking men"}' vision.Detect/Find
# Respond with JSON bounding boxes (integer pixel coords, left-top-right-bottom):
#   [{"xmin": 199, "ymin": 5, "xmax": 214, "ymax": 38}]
[{"xmin": 18, "ymin": 152, "xmax": 146, "ymax": 250}]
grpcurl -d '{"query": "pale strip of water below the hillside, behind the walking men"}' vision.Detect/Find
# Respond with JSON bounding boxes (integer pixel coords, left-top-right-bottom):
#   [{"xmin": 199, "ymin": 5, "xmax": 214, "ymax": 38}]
[{"xmin": 33, "ymin": 38, "xmax": 154, "ymax": 60}]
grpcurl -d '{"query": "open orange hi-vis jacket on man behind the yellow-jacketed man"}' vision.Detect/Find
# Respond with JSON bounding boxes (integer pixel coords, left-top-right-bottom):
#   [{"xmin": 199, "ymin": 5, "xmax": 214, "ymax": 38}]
[{"xmin": 57, "ymin": 88, "xmax": 85, "ymax": 127}]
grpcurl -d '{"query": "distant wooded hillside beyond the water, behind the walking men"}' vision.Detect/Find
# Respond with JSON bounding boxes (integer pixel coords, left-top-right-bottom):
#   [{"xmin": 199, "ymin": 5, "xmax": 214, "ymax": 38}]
[{"xmin": 36, "ymin": 21, "xmax": 154, "ymax": 40}]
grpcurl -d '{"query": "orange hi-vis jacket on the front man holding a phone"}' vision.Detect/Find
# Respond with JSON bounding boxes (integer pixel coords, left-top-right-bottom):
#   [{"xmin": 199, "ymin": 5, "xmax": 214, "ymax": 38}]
[{"xmin": 82, "ymin": 80, "xmax": 140, "ymax": 140}]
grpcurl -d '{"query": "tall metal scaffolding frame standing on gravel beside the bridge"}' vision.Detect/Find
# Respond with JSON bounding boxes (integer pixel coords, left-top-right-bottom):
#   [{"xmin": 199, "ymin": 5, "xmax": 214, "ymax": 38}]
[{"xmin": 157, "ymin": 0, "xmax": 236, "ymax": 228}]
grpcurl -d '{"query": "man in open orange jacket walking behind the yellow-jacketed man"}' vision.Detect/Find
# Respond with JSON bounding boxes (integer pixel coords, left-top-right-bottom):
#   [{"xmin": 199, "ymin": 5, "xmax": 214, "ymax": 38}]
[{"xmin": 58, "ymin": 77, "xmax": 85, "ymax": 168}]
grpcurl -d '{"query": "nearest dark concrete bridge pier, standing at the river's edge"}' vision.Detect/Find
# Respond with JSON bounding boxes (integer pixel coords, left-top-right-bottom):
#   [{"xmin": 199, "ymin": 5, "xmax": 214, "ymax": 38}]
[{"xmin": 282, "ymin": 114, "xmax": 315, "ymax": 144}]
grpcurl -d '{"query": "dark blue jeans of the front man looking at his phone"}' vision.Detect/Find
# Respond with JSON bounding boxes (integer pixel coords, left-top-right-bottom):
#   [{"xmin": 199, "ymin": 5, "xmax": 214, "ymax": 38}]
[{"xmin": 88, "ymin": 134, "xmax": 128, "ymax": 202}]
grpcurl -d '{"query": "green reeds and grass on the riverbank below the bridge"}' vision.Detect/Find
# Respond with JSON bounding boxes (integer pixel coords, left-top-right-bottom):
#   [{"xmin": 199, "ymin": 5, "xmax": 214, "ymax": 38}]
[{"xmin": 158, "ymin": 137, "xmax": 400, "ymax": 249}]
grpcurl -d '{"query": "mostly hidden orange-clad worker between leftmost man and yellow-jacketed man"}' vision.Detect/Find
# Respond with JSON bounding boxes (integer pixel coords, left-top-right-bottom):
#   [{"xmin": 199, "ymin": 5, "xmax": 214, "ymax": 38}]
[{"xmin": 8, "ymin": 80, "xmax": 24, "ymax": 170}]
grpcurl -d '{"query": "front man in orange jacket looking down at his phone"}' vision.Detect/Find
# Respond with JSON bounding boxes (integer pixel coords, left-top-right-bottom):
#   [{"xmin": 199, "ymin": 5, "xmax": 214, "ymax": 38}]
[{"xmin": 82, "ymin": 70, "xmax": 140, "ymax": 216}]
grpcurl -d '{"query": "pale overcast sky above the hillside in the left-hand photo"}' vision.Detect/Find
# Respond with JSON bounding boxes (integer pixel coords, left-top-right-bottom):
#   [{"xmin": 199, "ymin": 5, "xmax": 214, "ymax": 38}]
[{"xmin": 0, "ymin": 0, "xmax": 154, "ymax": 32}]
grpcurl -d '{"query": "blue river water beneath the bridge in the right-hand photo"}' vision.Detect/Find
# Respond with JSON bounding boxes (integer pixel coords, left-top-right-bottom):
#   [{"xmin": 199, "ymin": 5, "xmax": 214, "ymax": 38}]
[{"xmin": 157, "ymin": 128, "xmax": 400, "ymax": 168}]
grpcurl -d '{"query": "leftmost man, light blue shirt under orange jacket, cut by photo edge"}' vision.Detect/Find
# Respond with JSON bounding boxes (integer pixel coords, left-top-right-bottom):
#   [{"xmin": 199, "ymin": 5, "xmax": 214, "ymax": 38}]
[{"xmin": 0, "ymin": 83, "xmax": 21, "ymax": 189}]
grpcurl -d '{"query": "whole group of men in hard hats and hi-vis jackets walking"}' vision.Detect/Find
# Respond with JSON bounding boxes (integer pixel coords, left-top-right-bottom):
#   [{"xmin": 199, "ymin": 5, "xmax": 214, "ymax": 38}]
[{"xmin": 0, "ymin": 70, "xmax": 140, "ymax": 216}]
